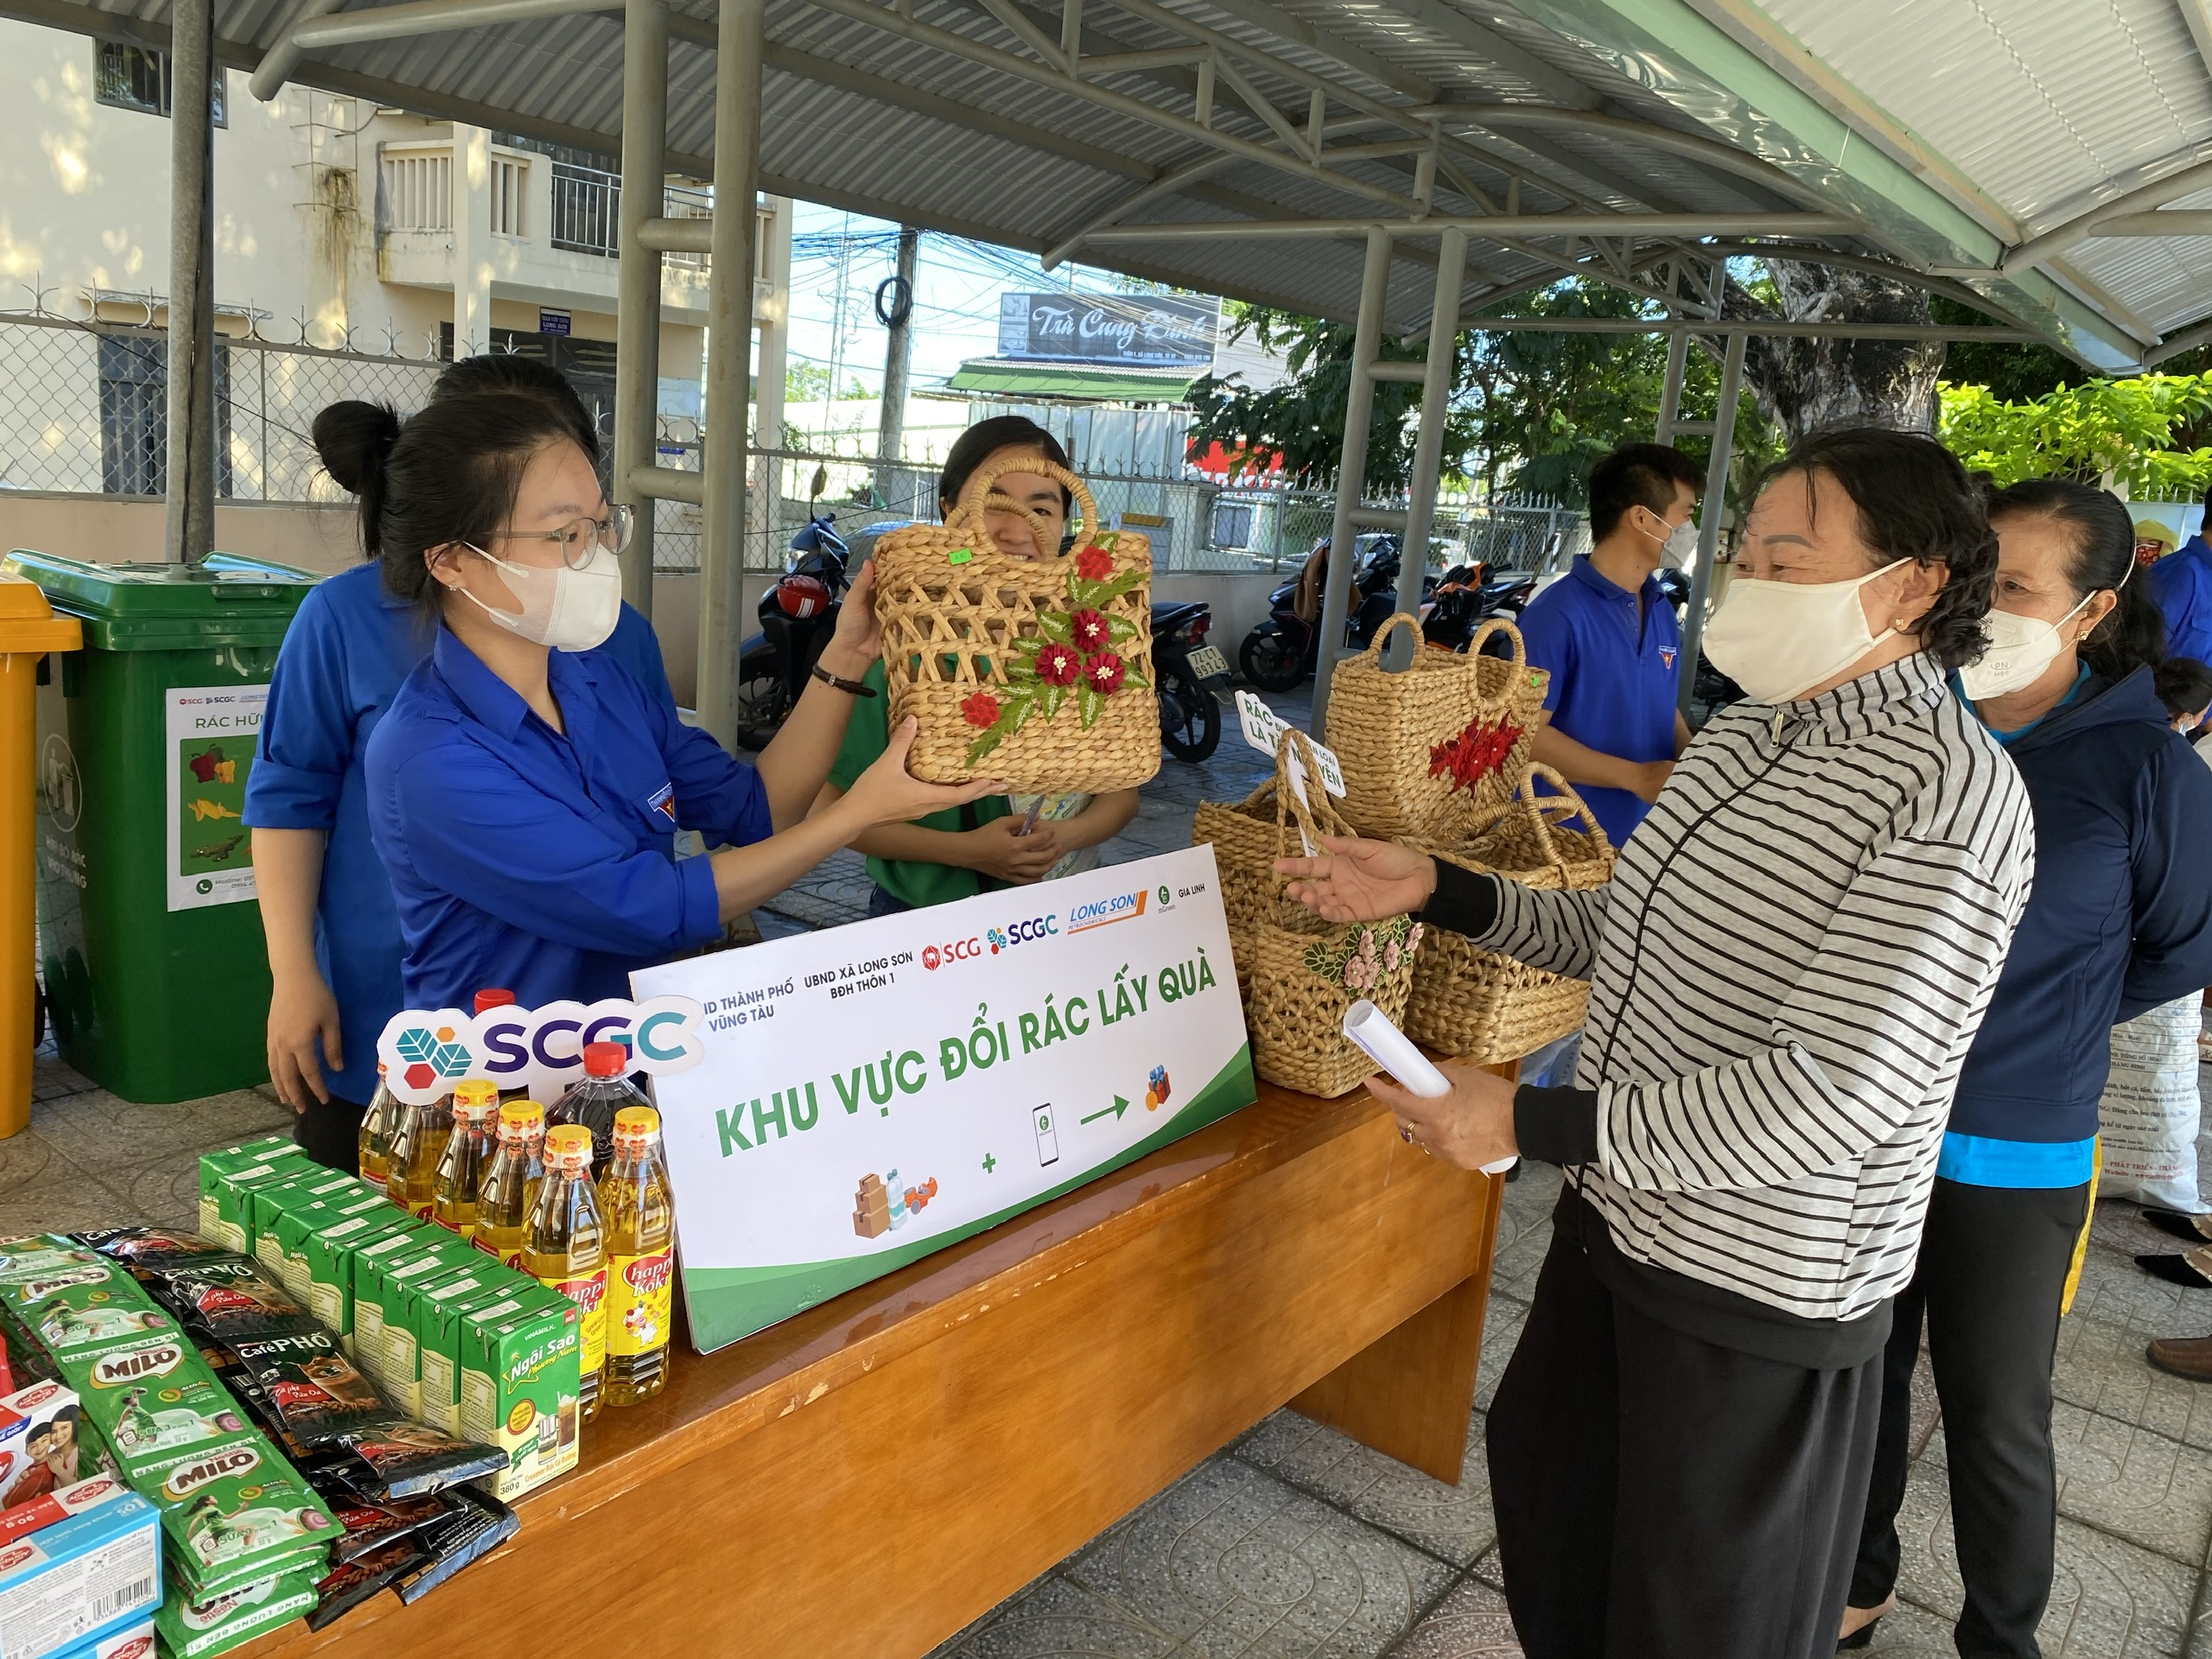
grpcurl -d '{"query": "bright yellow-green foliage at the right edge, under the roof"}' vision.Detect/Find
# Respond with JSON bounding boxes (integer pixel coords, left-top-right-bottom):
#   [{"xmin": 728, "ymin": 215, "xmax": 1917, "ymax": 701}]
[{"xmin": 1938, "ymin": 374, "xmax": 2212, "ymax": 500}]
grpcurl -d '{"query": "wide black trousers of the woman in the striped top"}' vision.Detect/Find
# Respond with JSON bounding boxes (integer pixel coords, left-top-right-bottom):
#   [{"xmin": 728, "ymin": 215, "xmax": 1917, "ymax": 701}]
[{"xmin": 1489, "ymin": 1236, "xmax": 1880, "ymax": 1659}]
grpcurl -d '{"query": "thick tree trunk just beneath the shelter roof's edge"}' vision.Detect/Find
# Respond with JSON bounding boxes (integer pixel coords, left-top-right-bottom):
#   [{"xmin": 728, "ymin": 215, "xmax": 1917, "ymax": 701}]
[{"xmin": 1723, "ymin": 259, "xmax": 1944, "ymax": 442}]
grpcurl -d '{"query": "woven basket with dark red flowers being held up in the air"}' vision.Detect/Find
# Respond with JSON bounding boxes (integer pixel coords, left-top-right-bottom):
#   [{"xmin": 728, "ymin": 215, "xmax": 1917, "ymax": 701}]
[{"xmin": 874, "ymin": 455, "xmax": 1159, "ymax": 794}]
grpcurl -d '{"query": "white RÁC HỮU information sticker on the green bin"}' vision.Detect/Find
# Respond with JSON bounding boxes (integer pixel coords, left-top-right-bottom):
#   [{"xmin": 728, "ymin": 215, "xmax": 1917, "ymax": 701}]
[{"xmin": 166, "ymin": 686, "xmax": 270, "ymax": 925}]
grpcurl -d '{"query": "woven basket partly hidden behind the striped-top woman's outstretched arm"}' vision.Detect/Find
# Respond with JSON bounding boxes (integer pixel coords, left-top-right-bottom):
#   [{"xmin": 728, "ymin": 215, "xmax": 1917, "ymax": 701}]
[{"xmin": 1405, "ymin": 766, "xmax": 1612, "ymax": 1066}]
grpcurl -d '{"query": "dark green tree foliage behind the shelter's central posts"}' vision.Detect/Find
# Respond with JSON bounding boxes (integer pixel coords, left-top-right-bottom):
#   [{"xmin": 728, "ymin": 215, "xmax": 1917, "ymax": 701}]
[{"xmin": 1190, "ymin": 279, "xmax": 1777, "ymax": 505}]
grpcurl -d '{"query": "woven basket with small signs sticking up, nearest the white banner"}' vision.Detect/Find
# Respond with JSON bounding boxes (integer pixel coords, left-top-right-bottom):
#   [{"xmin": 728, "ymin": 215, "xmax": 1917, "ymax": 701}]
[{"xmin": 1245, "ymin": 732, "xmax": 1433, "ymax": 1097}]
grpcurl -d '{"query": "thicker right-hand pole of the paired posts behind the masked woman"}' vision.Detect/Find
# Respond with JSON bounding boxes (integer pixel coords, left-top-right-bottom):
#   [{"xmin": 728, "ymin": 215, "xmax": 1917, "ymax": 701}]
[{"xmin": 699, "ymin": 0, "xmax": 767, "ymax": 750}]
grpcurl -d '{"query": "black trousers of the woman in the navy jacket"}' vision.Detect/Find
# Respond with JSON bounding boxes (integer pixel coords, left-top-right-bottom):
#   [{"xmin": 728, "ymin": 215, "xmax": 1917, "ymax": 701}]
[{"xmin": 1852, "ymin": 1181, "xmax": 2088, "ymax": 1659}]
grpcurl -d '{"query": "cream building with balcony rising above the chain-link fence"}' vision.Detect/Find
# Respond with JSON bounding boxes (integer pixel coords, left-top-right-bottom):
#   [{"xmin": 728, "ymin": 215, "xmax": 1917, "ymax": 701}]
[{"xmin": 0, "ymin": 20, "xmax": 710, "ymax": 429}]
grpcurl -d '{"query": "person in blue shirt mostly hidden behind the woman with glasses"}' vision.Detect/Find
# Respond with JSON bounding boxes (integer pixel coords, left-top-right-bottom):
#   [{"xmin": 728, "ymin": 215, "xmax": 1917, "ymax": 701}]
[{"xmin": 245, "ymin": 354, "xmax": 675, "ymax": 1168}]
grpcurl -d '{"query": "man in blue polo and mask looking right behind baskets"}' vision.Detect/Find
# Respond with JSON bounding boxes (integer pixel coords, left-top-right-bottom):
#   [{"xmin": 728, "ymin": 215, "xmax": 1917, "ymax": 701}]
[{"xmin": 1520, "ymin": 445, "xmax": 1706, "ymax": 847}]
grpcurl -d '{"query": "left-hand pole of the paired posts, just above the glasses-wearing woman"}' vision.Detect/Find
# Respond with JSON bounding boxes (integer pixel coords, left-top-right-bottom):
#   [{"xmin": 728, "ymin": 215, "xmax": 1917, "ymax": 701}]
[{"xmin": 615, "ymin": 0, "xmax": 668, "ymax": 620}]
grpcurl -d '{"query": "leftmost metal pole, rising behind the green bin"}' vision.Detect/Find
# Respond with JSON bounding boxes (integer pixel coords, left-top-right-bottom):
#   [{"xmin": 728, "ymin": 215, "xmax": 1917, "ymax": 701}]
[{"xmin": 166, "ymin": 0, "xmax": 214, "ymax": 564}]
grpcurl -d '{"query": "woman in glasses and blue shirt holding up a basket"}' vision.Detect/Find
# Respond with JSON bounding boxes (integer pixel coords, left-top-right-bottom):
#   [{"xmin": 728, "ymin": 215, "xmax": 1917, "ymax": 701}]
[{"xmin": 327, "ymin": 394, "xmax": 991, "ymax": 1026}]
